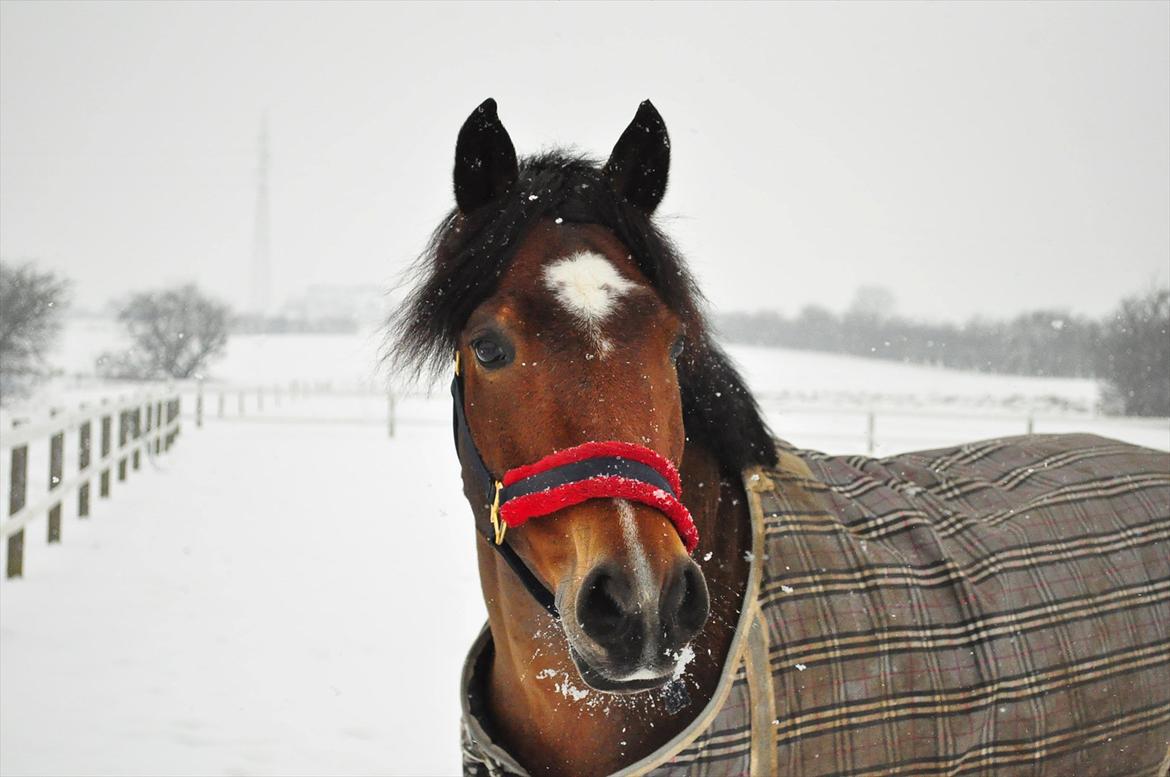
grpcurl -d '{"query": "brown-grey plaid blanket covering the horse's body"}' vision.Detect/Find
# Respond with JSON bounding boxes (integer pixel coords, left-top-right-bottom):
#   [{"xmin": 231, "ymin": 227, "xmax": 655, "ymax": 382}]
[{"xmin": 462, "ymin": 435, "xmax": 1170, "ymax": 777}]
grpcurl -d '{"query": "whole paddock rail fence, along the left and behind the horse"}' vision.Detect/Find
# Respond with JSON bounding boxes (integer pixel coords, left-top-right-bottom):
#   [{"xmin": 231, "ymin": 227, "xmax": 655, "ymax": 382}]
[{"xmin": 0, "ymin": 381, "xmax": 1170, "ymax": 577}]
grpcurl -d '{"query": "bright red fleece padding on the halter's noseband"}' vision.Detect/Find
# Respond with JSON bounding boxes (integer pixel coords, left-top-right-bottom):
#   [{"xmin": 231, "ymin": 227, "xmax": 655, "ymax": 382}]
[{"xmin": 500, "ymin": 442, "xmax": 698, "ymax": 553}]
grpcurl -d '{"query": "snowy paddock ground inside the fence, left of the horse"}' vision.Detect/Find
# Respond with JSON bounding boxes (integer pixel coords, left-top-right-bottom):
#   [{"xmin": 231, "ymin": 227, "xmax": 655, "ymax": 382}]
[{"xmin": 0, "ymin": 409, "xmax": 484, "ymax": 775}]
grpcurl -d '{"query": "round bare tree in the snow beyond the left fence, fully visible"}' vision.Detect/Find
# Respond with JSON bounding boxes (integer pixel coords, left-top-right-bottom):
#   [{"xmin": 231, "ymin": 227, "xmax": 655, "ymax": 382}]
[{"xmin": 98, "ymin": 284, "xmax": 230, "ymax": 379}]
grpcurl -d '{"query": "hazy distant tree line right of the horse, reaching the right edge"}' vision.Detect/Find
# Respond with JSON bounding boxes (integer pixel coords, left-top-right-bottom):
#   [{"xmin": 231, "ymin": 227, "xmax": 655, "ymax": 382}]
[{"xmin": 716, "ymin": 288, "xmax": 1170, "ymax": 415}]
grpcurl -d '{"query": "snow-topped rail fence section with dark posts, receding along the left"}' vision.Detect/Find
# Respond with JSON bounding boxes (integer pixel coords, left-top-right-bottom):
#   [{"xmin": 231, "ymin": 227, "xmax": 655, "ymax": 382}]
[{"xmin": 0, "ymin": 386, "xmax": 180, "ymax": 577}]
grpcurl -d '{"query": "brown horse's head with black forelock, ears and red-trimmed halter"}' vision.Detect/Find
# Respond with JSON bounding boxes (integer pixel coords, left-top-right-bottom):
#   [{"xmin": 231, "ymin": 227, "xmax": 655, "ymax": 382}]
[{"xmin": 395, "ymin": 99, "xmax": 771, "ymax": 693}]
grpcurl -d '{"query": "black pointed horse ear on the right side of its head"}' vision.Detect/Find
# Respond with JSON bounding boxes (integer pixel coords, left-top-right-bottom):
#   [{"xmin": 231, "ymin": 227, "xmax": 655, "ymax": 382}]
[{"xmin": 605, "ymin": 99, "xmax": 670, "ymax": 215}]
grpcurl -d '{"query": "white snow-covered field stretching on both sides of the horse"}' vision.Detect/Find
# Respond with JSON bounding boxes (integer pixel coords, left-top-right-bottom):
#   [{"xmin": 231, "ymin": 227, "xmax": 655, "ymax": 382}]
[{"xmin": 0, "ymin": 322, "xmax": 1170, "ymax": 775}]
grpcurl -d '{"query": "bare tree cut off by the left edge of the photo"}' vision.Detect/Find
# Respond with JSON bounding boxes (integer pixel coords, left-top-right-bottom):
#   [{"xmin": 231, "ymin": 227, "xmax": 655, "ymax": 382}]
[{"xmin": 0, "ymin": 262, "xmax": 69, "ymax": 399}]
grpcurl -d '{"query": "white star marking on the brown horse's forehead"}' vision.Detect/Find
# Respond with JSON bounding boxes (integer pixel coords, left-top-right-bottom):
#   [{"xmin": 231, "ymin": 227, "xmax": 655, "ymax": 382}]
[{"xmin": 544, "ymin": 250, "xmax": 638, "ymax": 356}]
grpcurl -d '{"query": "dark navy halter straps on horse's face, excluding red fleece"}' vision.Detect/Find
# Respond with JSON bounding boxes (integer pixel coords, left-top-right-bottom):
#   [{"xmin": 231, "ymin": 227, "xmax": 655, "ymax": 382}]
[{"xmin": 450, "ymin": 360, "xmax": 677, "ymax": 619}]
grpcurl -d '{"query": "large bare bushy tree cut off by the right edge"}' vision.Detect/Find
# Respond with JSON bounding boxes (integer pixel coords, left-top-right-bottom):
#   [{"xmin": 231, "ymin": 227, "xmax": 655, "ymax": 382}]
[{"xmin": 1099, "ymin": 287, "xmax": 1170, "ymax": 415}]
